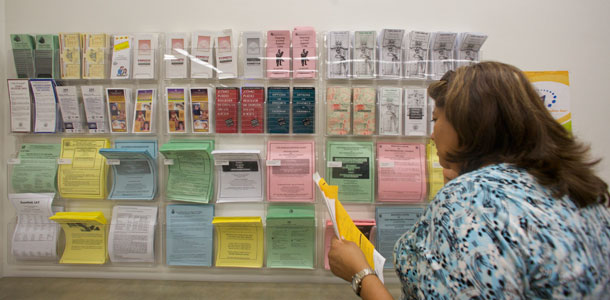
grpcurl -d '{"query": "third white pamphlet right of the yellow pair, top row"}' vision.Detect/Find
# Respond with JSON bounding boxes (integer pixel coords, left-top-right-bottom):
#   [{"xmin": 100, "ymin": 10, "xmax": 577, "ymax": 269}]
[{"xmin": 163, "ymin": 33, "xmax": 189, "ymax": 78}]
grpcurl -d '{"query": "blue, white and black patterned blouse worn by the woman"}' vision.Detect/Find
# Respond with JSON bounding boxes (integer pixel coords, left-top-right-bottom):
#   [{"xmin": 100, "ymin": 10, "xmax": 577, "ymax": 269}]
[{"xmin": 394, "ymin": 164, "xmax": 610, "ymax": 299}]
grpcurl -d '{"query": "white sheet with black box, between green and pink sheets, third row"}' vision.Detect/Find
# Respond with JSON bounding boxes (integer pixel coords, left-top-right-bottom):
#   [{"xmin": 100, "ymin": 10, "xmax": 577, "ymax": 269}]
[{"xmin": 212, "ymin": 150, "xmax": 263, "ymax": 203}]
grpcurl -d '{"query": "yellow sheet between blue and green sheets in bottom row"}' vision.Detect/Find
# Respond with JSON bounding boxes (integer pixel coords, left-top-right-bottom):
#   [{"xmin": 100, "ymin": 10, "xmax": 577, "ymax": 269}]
[{"xmin": 212, "ymin": 217, "xmax": 263, "ymax": 268}]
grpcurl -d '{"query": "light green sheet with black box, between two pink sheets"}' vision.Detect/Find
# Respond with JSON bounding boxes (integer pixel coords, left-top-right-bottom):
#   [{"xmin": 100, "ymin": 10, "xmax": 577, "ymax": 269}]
[{"xmin": 326, "ymin": 141, "xmax": 375, "ymax": 202}]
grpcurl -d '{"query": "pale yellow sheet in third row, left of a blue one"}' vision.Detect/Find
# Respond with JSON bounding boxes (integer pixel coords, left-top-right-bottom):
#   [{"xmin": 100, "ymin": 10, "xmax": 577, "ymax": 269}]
[{"xmin": 57, "ymin": 138, "xmax": 110, "ymax": 199}]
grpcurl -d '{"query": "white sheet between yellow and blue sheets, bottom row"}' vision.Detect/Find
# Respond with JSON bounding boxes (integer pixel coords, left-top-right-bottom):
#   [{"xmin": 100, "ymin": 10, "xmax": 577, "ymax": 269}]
[{"xmin": 108, "ymin": 205, "xmax": 157, "ymax": 263}]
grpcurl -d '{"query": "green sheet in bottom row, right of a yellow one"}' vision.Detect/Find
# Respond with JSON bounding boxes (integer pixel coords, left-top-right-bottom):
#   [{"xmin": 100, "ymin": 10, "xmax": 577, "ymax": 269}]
[{"xmin": 266, "ymin": 205, "xmax": 316, "ymax": 269}]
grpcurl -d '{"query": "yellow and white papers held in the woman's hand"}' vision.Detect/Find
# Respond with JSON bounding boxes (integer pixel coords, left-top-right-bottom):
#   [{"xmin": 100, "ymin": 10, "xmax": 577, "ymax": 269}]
[{"xmin": 313, "ymin": 172, "xmax": 385, "ymax": 282}]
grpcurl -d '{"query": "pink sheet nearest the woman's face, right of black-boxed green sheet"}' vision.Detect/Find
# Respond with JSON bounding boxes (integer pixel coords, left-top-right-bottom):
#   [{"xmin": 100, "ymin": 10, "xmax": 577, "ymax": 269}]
[{"xmin": 377, "ymin": 143, "xmax": 426, "ymax": 203}]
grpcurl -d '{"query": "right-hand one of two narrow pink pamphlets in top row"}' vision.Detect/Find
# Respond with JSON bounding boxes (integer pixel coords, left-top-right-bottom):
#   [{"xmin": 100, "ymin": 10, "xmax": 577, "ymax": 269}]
[{"xmin": 292, "ymin": 27, "xmax": 318, "ymax": 78}]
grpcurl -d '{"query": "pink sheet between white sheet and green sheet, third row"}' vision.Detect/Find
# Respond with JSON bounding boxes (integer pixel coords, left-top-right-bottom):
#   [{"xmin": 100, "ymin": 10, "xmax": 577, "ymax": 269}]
[{"xmin": 267, "ymin": 141, "xmax": 315, "ymax": 202}]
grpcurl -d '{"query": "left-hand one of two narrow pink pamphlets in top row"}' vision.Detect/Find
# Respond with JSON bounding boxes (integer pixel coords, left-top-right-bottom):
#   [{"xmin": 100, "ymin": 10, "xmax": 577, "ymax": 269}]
[{"xmin": 266, "ymin": 30, "xmax": 290, "ymax": 78}]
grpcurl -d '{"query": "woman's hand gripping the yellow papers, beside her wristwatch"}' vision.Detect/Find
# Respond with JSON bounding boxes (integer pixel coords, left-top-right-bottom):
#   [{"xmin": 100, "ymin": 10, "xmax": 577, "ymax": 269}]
[{"xmin": 328, "ymin": 236, "xmax": 370, "ymax": 282}]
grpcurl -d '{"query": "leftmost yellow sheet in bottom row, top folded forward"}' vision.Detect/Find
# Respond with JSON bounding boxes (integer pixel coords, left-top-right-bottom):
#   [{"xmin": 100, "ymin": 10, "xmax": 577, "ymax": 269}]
[{"xmin": 49, "ymin": 211, "xmax": 108, "ymax": 264}]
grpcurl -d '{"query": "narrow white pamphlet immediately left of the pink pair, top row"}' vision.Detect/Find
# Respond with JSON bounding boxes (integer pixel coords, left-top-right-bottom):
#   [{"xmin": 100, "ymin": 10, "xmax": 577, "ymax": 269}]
[{"xmin": 242, "ymin": 31, "xmax": 265, "ymax": 78}]
